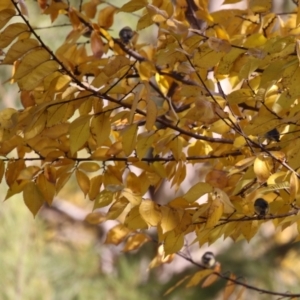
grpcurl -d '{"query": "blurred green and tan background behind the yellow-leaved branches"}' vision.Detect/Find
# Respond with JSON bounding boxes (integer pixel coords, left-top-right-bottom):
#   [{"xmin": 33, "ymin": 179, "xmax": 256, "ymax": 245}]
[{"xmin": 0, "ymin": 0, "xmax": 300, "ymax": 300}]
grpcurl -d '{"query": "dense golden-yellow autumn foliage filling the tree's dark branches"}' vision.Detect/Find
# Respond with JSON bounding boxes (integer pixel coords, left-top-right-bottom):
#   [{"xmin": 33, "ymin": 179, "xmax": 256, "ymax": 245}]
[{"xmin": 0, "ymin": 0, "xmax": 300, "ymax": 296}]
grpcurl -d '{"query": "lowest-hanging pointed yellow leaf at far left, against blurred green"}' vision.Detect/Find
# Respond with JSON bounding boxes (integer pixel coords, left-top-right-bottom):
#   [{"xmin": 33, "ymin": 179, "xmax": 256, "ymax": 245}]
[{"xmin": 23, "ymin": 182, "xmax": 44, "ymax": 216}]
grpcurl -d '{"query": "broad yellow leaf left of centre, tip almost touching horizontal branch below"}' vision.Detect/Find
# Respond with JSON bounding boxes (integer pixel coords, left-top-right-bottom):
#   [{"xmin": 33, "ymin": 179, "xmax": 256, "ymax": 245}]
[{"xmin": 69, "ymin": 116, "xmax": 90, "ymax": 155}]
